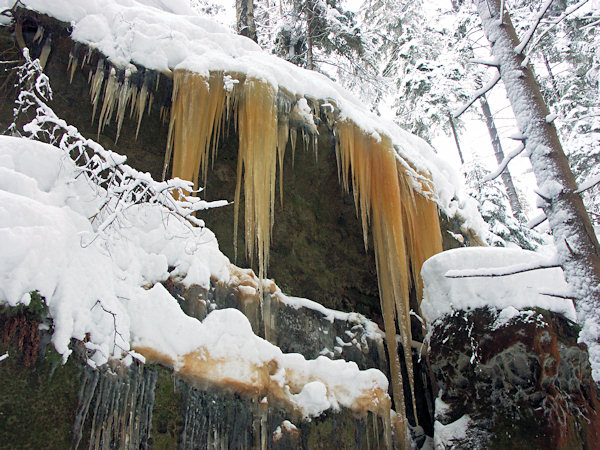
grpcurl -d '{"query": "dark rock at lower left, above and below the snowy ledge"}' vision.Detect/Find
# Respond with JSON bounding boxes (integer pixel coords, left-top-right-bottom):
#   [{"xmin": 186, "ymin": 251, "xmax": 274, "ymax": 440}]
[{"xmin": 0, "ymin": 280, "xmax": 390, "ymax": 449}]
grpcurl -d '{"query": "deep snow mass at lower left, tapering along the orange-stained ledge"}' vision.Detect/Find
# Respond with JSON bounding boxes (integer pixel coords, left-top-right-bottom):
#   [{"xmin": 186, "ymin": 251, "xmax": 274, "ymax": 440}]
[{"xmin": 0, "ymin": 136, "xmax": 388, "ymax": 417}]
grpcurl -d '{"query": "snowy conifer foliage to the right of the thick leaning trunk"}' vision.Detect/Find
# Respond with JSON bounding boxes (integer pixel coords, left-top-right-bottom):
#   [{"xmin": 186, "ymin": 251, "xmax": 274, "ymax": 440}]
[{"xmin": 513, "ymin": 0, "xmax": 600, "ymax": 226}]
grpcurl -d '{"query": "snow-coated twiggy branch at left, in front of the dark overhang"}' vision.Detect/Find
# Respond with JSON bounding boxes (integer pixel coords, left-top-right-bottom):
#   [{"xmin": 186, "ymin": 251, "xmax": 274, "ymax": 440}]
[{"xmin": 9, "ymin": 48, "xmax": 227, "ymax": 241}]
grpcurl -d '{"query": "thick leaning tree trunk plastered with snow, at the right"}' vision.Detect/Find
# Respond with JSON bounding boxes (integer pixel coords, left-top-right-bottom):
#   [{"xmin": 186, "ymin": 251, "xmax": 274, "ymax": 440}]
[{"xmin": 477, "ymin": 0, "xmax": 600, "ymax": 381}]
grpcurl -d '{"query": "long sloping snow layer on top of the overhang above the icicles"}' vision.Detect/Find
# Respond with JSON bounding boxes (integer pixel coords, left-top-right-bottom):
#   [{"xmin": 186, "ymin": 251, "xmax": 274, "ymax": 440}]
[{"xmin": 0, "ymin": 0, "xmax": 481, "ymax": 227}]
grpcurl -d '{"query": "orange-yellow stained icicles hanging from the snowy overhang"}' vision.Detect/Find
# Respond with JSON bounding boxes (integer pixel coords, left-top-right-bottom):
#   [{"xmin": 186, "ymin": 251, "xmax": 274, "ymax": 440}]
[{"xmin": 166, "ymin": 67, "xmax": 442, "ymax": 423}]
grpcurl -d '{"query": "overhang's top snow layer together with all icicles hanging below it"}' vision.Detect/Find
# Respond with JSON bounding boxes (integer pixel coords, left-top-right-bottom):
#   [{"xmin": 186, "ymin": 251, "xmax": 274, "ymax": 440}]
[{"xmin": 0, "ymin": 0, "xmax": 477, "ymax": 430}]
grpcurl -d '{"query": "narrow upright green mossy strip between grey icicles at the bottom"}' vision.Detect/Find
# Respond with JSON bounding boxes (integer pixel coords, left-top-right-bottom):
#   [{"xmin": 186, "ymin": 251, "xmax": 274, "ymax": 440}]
[{"xmin": 152, "ymin": 366, "xmax": 182, "ymax": 449}]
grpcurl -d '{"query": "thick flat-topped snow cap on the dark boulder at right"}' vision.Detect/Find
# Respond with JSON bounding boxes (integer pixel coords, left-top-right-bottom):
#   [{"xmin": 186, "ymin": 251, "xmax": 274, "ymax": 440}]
[{"xmin": 421, "ymin": 247, "xmax": 576, "ymax": 323}]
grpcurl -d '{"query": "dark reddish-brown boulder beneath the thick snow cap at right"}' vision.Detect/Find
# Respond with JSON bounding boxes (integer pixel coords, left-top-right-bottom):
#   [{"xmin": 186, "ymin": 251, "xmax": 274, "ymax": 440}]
[{"xmin": 429, "ymin": 308, "xmax": 600, "ymax": 449}]
